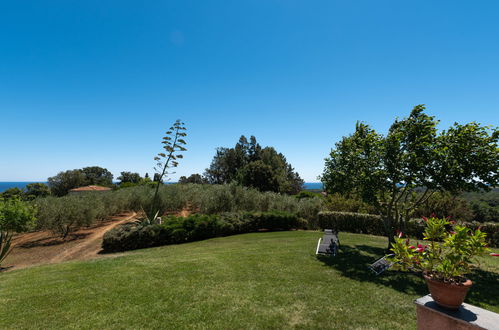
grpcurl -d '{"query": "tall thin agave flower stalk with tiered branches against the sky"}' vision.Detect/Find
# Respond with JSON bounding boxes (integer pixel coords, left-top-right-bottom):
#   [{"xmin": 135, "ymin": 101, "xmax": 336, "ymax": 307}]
[{"xmin": 146, "ymin": 120, "xmax": 187, "ymax": 223}]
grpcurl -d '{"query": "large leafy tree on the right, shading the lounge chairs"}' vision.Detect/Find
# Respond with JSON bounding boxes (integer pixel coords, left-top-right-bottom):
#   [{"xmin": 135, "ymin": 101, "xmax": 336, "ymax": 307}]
[{"xmin": 321, "ymin": 105, "xmax": 499, "ymax": 248}]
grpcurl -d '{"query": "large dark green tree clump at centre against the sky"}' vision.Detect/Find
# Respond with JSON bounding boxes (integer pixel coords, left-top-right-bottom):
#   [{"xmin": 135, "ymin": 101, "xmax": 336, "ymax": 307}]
[{"xmin": 205, "ymin": 135, "xmax": 303, "ymax": 194}]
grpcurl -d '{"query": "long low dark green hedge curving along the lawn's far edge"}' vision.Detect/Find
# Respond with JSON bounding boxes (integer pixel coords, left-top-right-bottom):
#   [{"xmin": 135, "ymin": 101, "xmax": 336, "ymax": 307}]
[{"xmin": 102, "ymin": 211, "xmax": 307, "ymax": 252}]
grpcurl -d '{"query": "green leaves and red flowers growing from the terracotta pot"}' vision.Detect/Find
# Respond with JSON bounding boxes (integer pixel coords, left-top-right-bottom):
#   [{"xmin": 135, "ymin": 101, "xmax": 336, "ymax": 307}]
[{"xmin": 391, "ymin": 217, "xmax": 488, "ymax": 283}]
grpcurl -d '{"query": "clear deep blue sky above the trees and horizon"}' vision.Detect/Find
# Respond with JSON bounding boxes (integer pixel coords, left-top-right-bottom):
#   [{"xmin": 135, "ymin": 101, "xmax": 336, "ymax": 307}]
[{"xmin": 0, "ymin": 0, "xmax": 499, "ymax": 181}]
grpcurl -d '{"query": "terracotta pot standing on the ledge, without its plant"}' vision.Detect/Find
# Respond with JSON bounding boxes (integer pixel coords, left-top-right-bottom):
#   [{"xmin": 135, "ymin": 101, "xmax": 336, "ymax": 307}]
[{"xmin": 423, "ymin": 274, "xmax": 473, "ymax": 309}]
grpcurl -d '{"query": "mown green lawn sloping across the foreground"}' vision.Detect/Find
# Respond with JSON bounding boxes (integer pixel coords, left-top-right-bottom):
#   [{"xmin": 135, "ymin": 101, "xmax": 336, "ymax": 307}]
[{"xmin": 0, "ymin": 231, "xmax": 499, "ymax": 329}]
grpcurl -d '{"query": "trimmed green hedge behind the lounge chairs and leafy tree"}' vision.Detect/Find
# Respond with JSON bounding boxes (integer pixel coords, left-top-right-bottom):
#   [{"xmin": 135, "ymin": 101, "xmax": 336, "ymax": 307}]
[{"xmin": 317, "ymin": 211, "xmax": 499, "ymax": 247}]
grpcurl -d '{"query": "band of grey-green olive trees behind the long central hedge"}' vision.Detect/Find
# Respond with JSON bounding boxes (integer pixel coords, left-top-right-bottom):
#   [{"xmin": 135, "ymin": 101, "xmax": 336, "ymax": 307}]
[{"xmin": 31, "ymin": 184, "xmax": 323, "ymax": 237}]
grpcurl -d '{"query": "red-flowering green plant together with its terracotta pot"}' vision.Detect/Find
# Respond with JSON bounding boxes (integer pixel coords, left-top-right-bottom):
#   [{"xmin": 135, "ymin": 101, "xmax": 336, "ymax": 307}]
[{"xmin": 391, "ymin": 217, "xmax": 488, "ymax": 309}]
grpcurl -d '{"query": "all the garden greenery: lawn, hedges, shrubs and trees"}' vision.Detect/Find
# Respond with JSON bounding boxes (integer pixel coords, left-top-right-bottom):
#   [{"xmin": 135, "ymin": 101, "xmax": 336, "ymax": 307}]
[{"xmin": 0, "ymin": 110, "xmax": 499, "ymax": 329}]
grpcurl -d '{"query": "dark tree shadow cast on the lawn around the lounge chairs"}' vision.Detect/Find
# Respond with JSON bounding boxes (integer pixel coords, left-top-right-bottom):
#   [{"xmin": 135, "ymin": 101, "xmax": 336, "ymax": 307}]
[{"xmin": 317, "ymin": 245, "xmax": 499, "ymax": 306}]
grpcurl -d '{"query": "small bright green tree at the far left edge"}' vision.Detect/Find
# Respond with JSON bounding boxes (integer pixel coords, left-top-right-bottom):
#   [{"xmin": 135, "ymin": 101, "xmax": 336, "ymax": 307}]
[{"xmin": 0, "ymin": 197, "xmax": 35, "ymax": 265}]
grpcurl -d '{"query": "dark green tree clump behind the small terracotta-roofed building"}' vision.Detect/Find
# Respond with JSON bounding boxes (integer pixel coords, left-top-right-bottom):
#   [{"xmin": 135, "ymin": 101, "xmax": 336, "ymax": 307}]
[{"xmin": 48, "ymin": 166, "xmax": 113, "ymax": 196}]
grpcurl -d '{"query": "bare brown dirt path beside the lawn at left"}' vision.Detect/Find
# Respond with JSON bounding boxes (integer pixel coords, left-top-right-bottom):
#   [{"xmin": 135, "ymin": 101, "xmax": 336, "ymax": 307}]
[{"xmin": 2, "ymin": 212, "xmax": 136, "ymax": 270}]
